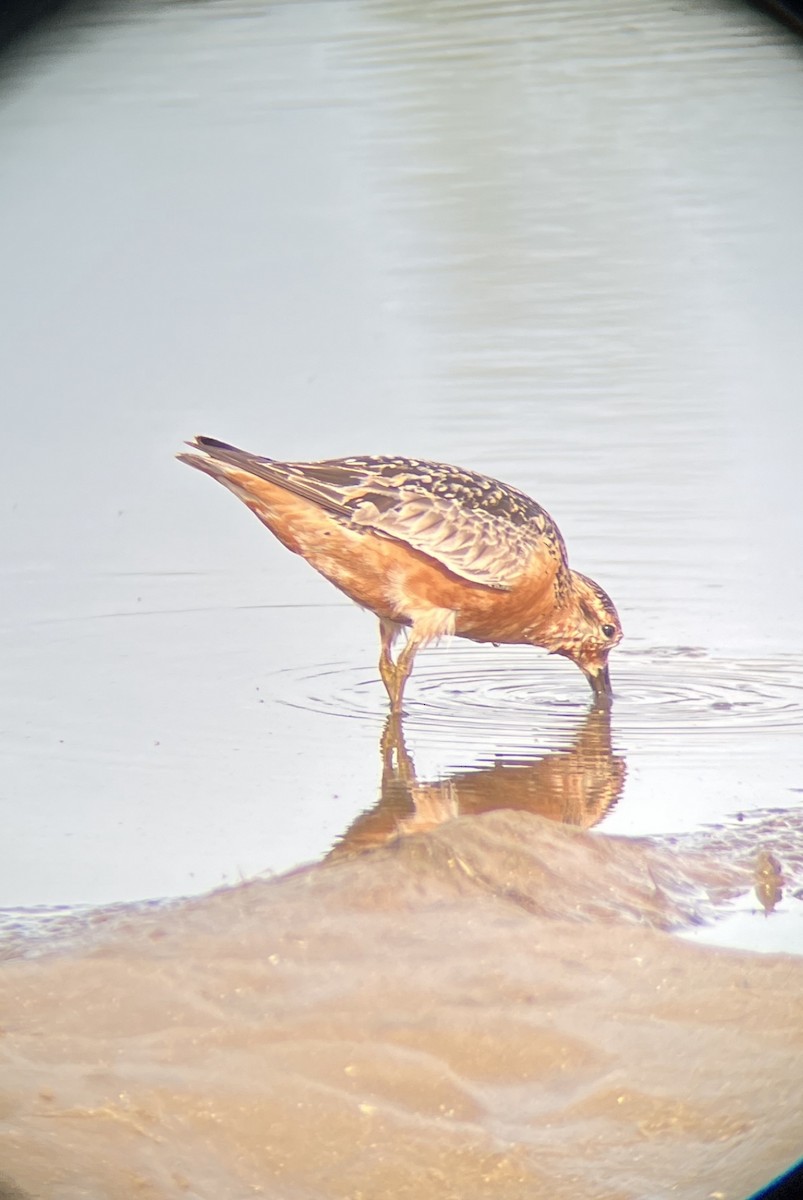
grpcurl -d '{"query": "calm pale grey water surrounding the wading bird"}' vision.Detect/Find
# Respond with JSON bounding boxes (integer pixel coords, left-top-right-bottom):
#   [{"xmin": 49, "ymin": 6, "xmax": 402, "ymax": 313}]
[{"xmin": 0, "ymin": 0, "xmax": 803, "ymax": 949}]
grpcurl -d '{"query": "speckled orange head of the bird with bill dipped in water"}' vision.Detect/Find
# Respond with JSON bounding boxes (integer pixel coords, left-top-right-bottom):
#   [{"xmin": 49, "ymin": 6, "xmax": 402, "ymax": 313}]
[{"xmin": 546, "ymin": 571, "xmax": 622, "ymax": 700}]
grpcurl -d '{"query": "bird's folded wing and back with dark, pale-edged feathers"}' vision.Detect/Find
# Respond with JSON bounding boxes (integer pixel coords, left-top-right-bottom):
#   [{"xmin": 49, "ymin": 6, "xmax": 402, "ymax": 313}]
[{"xmin": 184, "ymin": 438, "xmax": 567, "ymax": 590}]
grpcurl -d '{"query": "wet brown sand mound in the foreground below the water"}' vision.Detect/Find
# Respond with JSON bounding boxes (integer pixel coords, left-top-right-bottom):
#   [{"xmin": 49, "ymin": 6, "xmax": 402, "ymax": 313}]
[{"xmin": 0, "ymin": 811, "xmax": 803, "ymax": 1200}]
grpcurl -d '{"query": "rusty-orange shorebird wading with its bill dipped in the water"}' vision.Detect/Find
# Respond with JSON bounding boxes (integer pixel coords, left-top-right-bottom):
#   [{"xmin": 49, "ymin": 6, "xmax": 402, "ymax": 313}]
[{"xmin": 178, "ymin": 437, "xmax": 622, "ymax": 712}]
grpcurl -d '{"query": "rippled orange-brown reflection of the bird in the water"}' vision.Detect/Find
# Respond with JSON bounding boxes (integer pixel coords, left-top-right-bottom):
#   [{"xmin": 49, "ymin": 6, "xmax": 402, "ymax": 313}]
[{"xmin": 329, "ymin": 703, "xmax": 627, "ymax": 858}]
